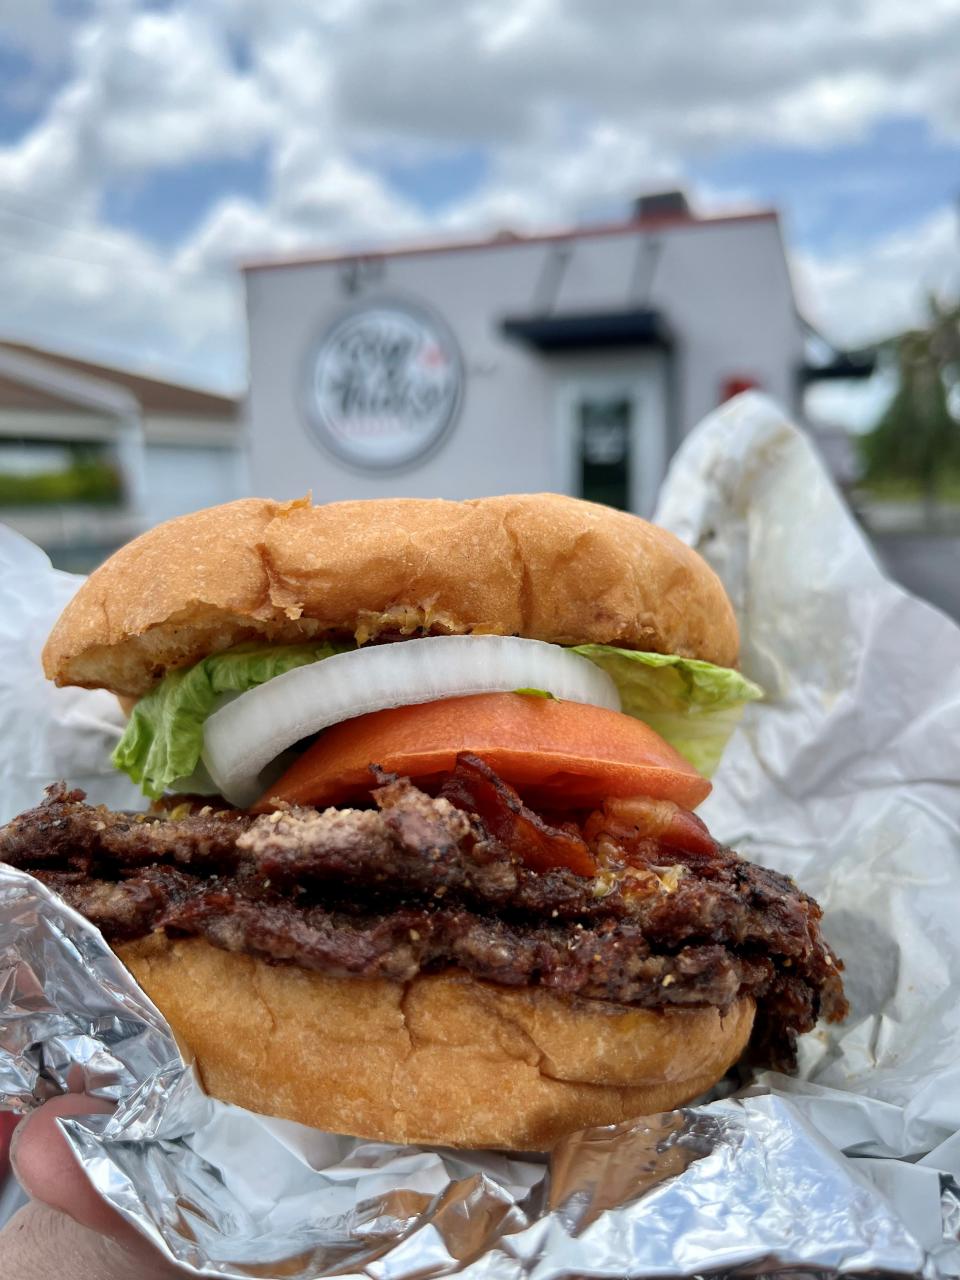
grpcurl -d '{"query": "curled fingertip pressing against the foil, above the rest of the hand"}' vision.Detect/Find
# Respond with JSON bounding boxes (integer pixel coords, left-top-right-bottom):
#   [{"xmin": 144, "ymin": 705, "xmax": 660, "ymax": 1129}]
[{"xmin": 10, "ymin": 1093, "xmax": 146, "ymax": 1247}]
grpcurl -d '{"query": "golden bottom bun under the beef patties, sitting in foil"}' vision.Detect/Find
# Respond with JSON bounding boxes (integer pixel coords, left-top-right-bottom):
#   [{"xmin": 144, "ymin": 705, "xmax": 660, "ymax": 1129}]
[{"xmin": 116, "ymin": 933, "xmax": 754, "ymax": 1151}]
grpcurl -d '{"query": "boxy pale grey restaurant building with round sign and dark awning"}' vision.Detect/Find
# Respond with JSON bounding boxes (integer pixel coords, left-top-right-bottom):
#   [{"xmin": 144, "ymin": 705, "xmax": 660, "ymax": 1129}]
[{"xmin": 244, "ymin": 192, "xmax": 805, "ymax": 513}]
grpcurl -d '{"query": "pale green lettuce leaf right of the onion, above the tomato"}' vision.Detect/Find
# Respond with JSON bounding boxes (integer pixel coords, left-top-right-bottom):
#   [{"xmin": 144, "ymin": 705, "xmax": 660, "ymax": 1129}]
[{"xmin": 573, "ymin": 644, "xmax": 763, "ymax": 777}]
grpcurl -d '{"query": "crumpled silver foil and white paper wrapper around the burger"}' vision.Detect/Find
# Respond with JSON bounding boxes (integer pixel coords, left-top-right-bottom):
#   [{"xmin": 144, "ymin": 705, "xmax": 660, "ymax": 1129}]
[{"xmin": 0, "ymin": 396, "xmax": 960, "ymax": 1280}]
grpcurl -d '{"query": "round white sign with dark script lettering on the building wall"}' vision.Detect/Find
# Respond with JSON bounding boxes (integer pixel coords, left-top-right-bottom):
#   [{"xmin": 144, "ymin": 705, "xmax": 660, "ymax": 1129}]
[{"xmin": 307, "ymin": 303, "xmax": 463, "ymax": 468}]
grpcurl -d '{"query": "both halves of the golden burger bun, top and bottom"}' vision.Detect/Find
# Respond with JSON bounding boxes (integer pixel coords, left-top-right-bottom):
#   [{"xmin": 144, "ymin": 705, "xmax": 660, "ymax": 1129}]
[{"xmin": 50, "ymin": 494, "xmax": 754, "ymax": 1149}]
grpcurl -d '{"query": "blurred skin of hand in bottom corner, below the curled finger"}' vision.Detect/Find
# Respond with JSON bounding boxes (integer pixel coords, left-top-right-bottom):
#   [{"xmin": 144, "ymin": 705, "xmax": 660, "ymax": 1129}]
[{"xmin": 0, "ymin": 1202, "xmax": 187, "ymax": 1280}]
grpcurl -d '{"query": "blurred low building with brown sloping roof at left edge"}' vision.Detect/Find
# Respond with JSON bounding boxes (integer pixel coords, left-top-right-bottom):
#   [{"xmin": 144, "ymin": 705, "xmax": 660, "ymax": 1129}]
[{"xmin": 0, "ymin": 342, "xmax": 247, "ymax": 572}]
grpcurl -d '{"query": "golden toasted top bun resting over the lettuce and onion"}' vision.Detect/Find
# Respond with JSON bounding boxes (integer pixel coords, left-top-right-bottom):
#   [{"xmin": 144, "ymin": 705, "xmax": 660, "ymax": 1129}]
[{"xmin": 44, "ymin": 494, "xmax": 739, "ymax": 696}]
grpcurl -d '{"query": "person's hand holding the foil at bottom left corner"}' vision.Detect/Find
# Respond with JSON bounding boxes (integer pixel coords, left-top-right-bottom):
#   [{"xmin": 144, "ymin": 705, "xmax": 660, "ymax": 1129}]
[{"xmin": 0, "ymin": 1093, "xmax": 188, "ymax": 1280}]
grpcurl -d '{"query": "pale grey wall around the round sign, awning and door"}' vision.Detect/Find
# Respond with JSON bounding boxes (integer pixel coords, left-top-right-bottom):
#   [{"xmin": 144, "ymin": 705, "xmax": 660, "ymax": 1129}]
[{"xmin": 246, "ymin": 219, "xmax": 803, "ymax": 500}]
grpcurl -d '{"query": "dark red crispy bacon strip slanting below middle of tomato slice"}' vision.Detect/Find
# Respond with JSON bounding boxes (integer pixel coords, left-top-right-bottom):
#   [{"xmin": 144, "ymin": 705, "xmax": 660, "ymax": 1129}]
[{"xmin": 440, "ymin": 754, "xmax": 596, "ymax": 876}]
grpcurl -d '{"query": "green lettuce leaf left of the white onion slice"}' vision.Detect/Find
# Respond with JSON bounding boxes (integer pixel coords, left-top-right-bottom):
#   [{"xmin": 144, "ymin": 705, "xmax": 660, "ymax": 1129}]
[{"xmin": 113, "ymin": 643, "xmax": 353, "ymax": 799}]
